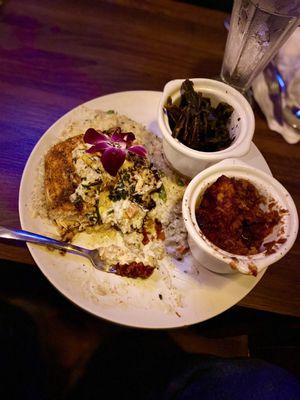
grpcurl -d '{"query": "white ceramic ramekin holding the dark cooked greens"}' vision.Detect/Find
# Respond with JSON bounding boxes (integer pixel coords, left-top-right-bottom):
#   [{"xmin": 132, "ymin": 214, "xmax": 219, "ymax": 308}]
[{"xmin": 158, "ymin": 78, "xmax": 255, "ymax": 178}]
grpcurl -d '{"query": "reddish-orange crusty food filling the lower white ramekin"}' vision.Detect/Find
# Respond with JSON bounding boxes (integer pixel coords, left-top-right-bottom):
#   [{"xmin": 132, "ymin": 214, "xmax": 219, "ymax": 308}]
[{"xmin": 196, "ymin": 175, "xmax": 281, "ymax": 255}]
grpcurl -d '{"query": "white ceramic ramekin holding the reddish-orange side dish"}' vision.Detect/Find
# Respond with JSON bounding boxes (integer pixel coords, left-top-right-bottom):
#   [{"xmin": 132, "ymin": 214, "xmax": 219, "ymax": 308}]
[{"xmin": 182, "ymin": 159, "xmax": 299, "ymax": 275}]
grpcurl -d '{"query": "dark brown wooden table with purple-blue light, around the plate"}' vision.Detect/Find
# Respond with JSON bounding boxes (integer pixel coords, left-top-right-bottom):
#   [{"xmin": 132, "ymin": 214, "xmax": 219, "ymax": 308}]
[{"xmin": 0, "ymin": 0, "xmax": 300, "ymax": 316}]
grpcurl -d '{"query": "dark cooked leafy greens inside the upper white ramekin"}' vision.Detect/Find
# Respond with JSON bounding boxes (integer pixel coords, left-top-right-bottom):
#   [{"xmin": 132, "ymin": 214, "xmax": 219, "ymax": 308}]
[{"xmin": 165, "ymin": 79, "xmax": 234, "ymax": 152}]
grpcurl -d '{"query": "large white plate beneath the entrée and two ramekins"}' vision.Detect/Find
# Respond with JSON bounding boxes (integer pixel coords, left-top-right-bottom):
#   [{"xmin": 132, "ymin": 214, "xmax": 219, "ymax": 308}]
[{"xmin": 19, "ymin": 91, "xmax": 271, "ymax": 329}]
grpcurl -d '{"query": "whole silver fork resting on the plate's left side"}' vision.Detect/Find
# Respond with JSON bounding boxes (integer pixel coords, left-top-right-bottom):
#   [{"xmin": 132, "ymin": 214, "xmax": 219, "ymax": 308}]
[{"xmin": 0, "ymin": 226, "xmax": 112, "ymax": 273}]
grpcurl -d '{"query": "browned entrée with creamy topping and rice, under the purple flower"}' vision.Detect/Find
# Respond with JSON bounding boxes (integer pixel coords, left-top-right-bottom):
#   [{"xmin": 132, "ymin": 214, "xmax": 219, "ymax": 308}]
[{"xmin": 43, "ymin": 110, "xmax": 188, "ymax": 277}]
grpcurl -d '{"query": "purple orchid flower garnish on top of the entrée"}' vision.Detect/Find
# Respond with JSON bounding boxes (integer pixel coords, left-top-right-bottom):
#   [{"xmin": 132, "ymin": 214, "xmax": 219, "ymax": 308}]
[{"xmin": 83, "ymin": 127, "xmax": 147, "ymax": 176}]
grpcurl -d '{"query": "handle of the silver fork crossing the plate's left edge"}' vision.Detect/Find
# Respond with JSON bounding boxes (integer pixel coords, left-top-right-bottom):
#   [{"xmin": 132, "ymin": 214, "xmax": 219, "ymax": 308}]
[{"xmin": 0, "ymin": 226, "xmax": 88, "ymax": 257}]
